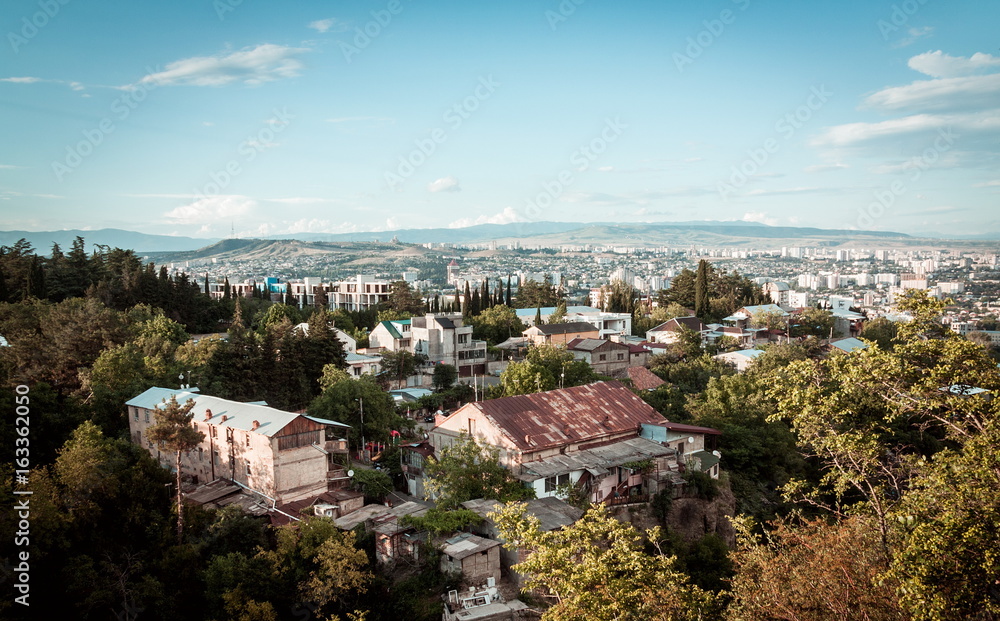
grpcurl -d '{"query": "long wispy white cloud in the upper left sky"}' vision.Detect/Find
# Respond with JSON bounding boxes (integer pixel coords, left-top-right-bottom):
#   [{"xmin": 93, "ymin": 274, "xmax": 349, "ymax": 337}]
[{"xmin": 140, "ymin": 43, "xmax": 308, "ymax": 86}]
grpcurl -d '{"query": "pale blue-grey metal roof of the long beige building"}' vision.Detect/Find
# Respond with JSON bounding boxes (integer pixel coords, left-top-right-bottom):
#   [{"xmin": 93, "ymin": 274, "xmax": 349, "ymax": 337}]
[{"xmin": 125, "ymin": 386, "xmax": 301, "ymax": 437}]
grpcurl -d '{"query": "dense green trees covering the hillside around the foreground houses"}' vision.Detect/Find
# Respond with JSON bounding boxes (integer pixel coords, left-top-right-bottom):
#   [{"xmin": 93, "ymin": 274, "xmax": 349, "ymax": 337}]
[{"xmin": 0, "ymin": 240, "xmax": 1000, "ymax": 621}]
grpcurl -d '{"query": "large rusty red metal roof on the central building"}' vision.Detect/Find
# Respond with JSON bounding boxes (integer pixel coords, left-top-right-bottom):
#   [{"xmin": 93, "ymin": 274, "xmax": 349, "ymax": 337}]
[{"xmin": 455, "ymin": 381, "xmax": 665, "ymax": 452}]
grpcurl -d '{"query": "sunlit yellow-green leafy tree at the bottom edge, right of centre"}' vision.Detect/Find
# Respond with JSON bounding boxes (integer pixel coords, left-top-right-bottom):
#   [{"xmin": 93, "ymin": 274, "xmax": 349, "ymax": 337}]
[{"xmin": 490, "ymin": 504, "xmax": 712, "ymax": 621}]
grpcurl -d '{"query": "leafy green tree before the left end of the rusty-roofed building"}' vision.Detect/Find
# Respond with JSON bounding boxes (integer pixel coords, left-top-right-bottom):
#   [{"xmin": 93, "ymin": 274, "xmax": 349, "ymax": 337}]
[{"xmin": 424, "ymin": 434, "xmax": 534, "ymax": 509}]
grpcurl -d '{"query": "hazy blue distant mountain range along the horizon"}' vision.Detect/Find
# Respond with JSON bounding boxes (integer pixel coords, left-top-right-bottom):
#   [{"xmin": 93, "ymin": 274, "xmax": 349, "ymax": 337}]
[{"xmin": 0, "ymin": 221, "xmax": 1000, "ymax": 256}]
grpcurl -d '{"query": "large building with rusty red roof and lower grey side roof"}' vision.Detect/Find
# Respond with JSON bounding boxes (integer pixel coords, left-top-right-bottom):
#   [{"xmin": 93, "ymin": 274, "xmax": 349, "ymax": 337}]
[{"xmin": 429, "ymin": 382, "xmax": 712, "ymax": 503}]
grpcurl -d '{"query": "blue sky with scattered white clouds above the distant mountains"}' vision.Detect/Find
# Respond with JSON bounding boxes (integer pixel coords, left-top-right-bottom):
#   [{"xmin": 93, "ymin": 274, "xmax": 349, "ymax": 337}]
[{"xmin": 0, "ymin": 0, "xmax": 1000, "ymax": 237}]
